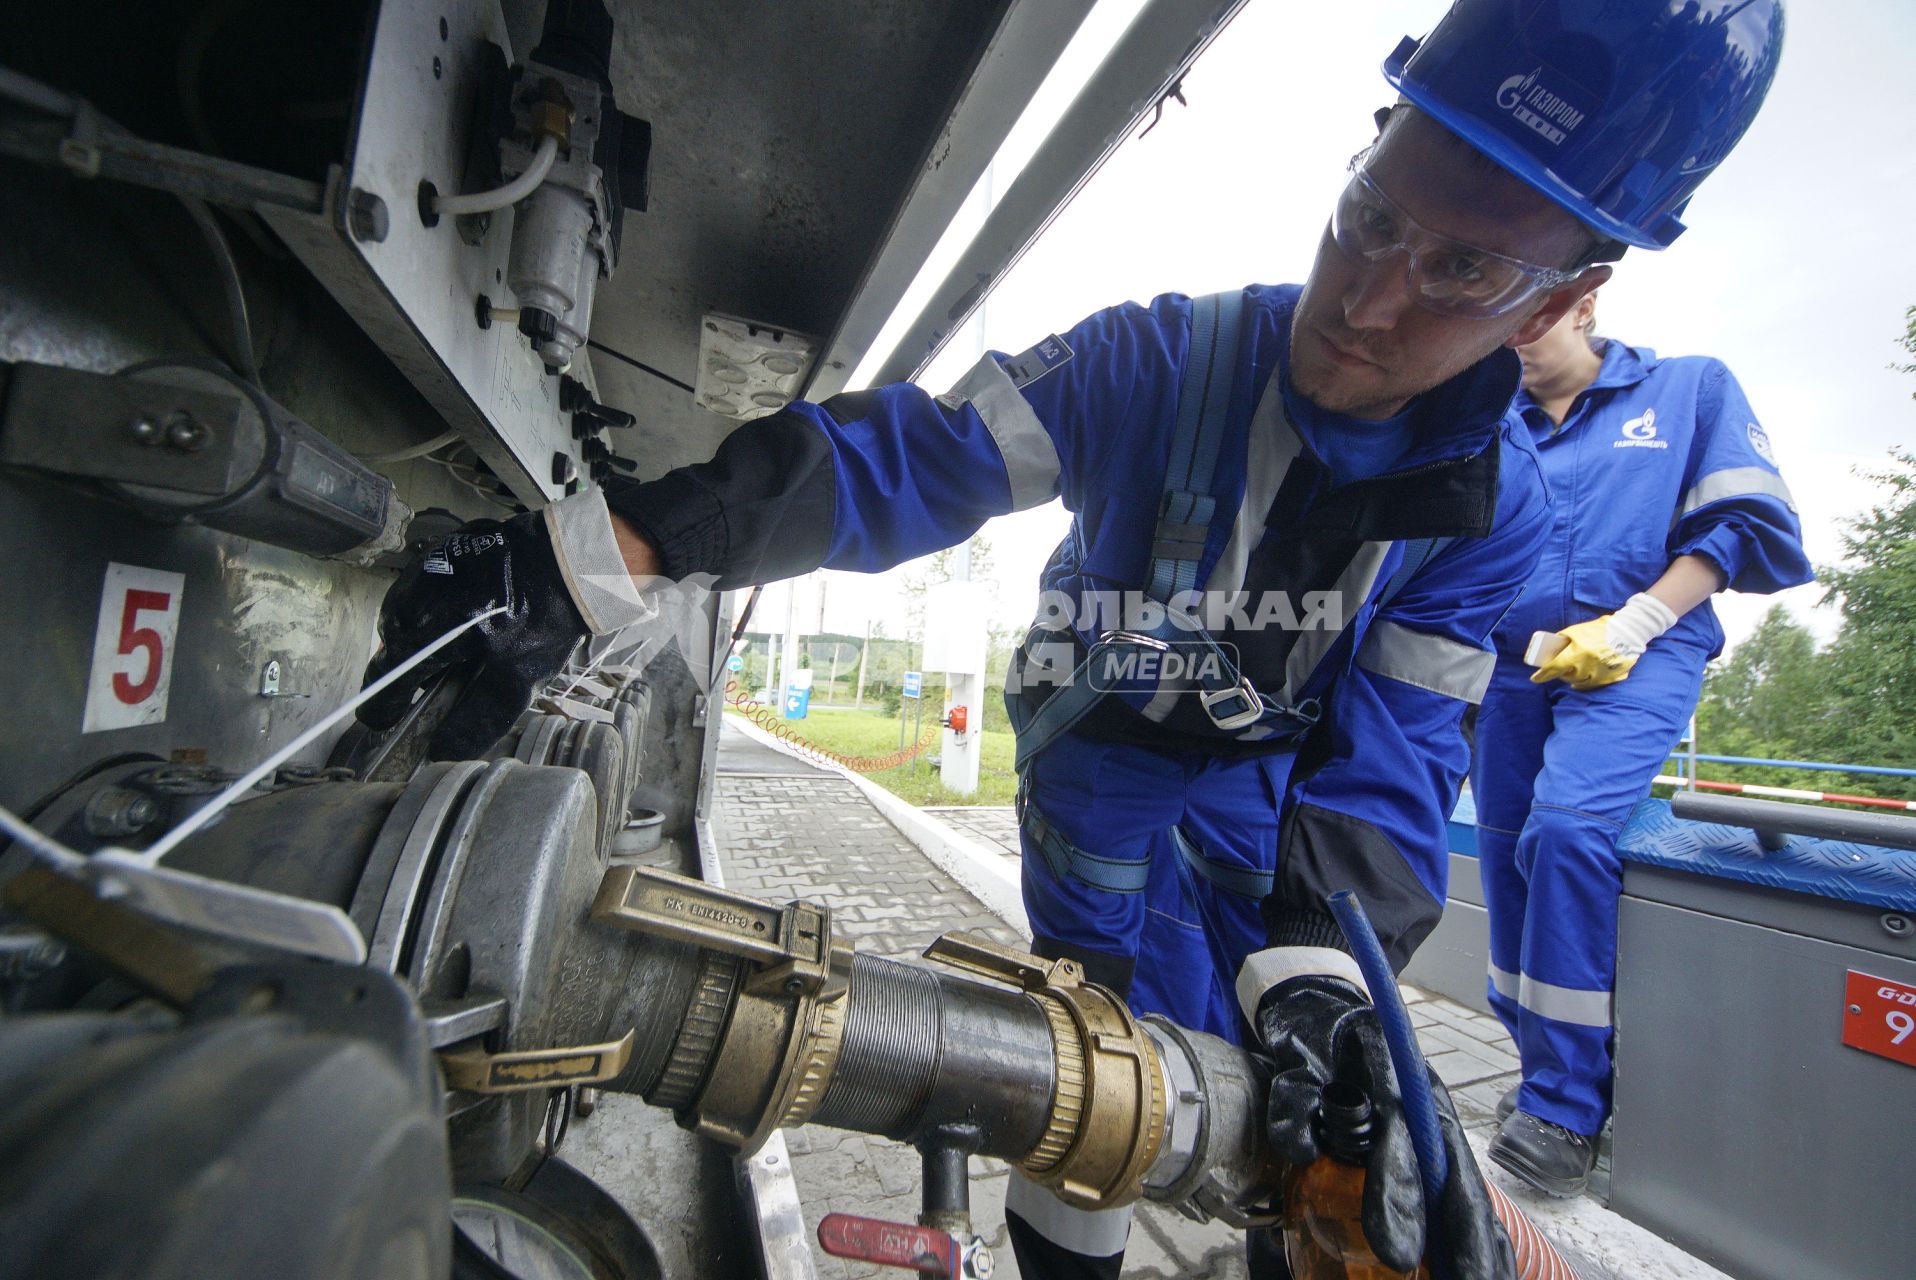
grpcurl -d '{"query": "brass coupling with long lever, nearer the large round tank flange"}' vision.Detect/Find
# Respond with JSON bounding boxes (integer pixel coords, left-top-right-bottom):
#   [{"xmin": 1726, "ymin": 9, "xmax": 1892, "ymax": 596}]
[{"xmin": 592, "ymin": 866, "xmax": 853, "ymax": 1155}]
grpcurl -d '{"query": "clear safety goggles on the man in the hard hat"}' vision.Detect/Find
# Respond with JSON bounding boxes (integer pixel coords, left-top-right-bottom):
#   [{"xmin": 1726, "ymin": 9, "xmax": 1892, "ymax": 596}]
[{"xmin": 1330, "ymin": 151, "xmax": 1581, "ymax": 318}]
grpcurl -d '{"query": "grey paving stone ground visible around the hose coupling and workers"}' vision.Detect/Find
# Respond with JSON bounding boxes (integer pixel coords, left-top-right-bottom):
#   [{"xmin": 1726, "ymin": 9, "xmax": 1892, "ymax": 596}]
[{"xmin": 715, "ymin": 736, "xmax": 1693, "ymax": 1280}]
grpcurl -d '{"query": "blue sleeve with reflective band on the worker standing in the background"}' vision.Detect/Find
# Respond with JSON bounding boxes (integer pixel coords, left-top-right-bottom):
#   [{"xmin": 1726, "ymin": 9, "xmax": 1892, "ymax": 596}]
[{"xmin": 1669, "ymin": 362, "xmax": 1814, "ymax": 592}]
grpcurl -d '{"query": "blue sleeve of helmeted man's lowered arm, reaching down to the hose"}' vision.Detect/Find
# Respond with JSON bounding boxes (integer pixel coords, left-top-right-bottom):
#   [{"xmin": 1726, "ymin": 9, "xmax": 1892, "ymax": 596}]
[{"xmin": 1265, "ymin": 434, "xmax": 1548, "ymax": 970}]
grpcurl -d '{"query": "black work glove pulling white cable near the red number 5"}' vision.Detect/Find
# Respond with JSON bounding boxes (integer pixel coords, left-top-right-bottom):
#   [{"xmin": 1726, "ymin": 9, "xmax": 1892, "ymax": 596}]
[{"xmin": 358, "ymin": 512, "xmax": 586, "ymax": 761}]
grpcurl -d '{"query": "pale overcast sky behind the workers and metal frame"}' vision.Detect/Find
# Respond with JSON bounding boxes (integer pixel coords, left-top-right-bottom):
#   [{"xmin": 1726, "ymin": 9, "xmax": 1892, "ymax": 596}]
[{"xmin": 761, "ymin": 0, "xmax": 1916, "ymax": 644}]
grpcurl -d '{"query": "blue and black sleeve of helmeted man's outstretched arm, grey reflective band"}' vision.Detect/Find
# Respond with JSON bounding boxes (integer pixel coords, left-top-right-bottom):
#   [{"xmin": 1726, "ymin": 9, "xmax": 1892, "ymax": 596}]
[{"xmin": 605, "ymin": 295, "xmax": 1190, "ymax": 586}]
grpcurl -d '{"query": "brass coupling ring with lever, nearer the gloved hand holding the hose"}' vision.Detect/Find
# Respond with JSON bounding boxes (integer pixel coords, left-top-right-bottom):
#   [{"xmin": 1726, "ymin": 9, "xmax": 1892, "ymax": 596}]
[{"xmin": 925, "ymin": 933, "xmax": 1165, "ymax": 1209}]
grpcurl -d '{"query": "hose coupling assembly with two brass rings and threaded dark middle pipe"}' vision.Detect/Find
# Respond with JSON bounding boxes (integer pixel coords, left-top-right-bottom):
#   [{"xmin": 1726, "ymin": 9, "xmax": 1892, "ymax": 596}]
[{"xmin": 592, "ymin": 866, "xmax": 1276, "ymax": 1224}]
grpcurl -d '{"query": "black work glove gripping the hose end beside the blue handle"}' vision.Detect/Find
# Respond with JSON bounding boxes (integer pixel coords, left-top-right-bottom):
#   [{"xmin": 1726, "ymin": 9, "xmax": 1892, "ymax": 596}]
[{"xmin": 1257, "ymin": 975, "xmax": 1516, "ymax": 1280}]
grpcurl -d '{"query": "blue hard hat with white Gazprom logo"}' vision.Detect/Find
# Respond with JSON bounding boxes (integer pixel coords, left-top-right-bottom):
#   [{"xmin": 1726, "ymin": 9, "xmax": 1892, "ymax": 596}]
[{"xmin": 1383, "ymin": 0, "xmax": 1784, "ymax": 249}]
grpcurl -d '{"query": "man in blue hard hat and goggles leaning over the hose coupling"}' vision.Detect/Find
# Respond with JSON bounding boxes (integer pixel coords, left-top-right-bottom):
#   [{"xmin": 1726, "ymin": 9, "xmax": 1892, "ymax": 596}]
[{"xmin": 362, "ymin": 0, "xmax": 1782, "ymax": 1278}]
